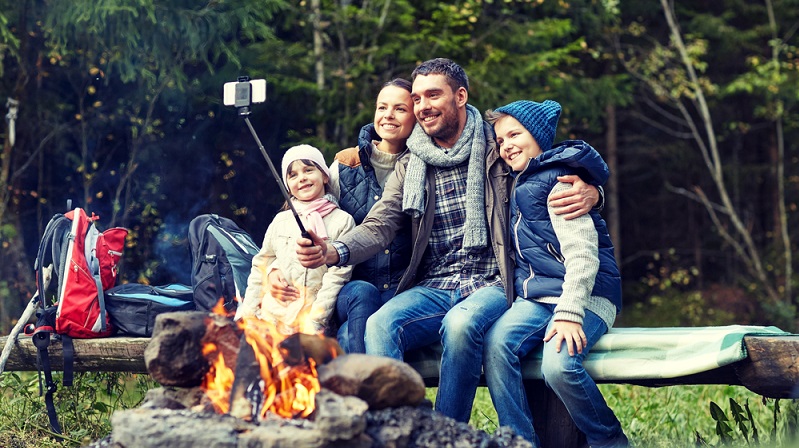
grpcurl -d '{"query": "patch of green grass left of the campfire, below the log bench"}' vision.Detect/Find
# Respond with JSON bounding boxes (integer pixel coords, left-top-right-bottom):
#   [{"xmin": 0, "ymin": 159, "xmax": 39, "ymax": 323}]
[{"xmin": 0, "ymin": 372, "xmax": 155, "ymax": 447}]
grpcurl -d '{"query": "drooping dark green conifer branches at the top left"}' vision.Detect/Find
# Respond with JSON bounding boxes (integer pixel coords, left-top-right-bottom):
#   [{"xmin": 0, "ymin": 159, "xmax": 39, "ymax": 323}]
[{"xmin": 45, "ymin": 0, "xmax": 285, "ymax": 89}]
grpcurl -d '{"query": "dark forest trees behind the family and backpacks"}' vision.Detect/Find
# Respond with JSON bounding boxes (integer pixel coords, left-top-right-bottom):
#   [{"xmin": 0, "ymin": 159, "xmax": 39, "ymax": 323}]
[{"xmin": 0, "ymin": 0, "xmax": 799, "ymax": 334}]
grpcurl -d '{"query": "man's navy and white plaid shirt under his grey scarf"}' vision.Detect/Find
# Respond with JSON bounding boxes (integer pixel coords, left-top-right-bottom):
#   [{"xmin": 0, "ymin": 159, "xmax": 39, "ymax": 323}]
[{"xmin": 418, "ymin": 161, "xmax": 502, "ymax": 298}]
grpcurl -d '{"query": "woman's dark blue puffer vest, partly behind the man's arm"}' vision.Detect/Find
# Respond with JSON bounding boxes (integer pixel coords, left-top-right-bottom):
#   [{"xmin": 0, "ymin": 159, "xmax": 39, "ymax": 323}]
[{"xmin": 339, "ymin": 123, "xmax": 411, "ymax": 291}]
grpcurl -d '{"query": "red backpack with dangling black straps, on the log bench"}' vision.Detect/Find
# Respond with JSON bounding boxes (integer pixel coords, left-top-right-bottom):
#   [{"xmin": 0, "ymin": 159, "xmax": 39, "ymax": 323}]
[{"xmin": 25, "ymin": 208, "xmax": 128, "ymax": 434}]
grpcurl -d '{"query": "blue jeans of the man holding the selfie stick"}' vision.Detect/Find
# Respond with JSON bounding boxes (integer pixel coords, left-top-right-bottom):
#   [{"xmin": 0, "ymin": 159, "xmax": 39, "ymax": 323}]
[{"xmin": 366, "ymin": 286, "xmax": 508, "ymax": 422}]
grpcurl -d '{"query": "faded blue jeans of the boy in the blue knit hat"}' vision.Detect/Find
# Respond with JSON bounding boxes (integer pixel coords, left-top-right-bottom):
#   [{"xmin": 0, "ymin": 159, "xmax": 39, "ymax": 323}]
[{"xmin": 484, "ymin": 298, "xmax": 627, "ymax": 447}]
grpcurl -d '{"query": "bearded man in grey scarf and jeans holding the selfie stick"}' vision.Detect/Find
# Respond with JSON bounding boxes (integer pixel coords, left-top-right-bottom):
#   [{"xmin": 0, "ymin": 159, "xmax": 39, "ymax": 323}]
[{"xmin": 297, "ymin": 58, "xmax": 599, "ymax": 422}]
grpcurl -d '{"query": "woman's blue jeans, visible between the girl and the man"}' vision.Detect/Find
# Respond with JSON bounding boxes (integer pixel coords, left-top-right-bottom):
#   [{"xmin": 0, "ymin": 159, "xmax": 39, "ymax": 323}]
[{"xmin": 336, "ymin": 280, "xmax": 397, "ymax": 353}]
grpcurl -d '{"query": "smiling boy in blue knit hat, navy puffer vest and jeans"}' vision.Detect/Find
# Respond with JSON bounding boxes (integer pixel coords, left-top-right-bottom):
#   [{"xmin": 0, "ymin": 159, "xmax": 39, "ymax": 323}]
[{"xmin": 483, "ymin": 100, "xmax": 627, "ymax": 447}]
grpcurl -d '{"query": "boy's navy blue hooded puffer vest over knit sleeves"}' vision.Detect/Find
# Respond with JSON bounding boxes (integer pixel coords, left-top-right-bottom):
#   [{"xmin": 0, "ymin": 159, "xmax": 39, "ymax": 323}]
[{"xmin": 510, "ymin": 140, "xmax": 621, "ymax": 313}]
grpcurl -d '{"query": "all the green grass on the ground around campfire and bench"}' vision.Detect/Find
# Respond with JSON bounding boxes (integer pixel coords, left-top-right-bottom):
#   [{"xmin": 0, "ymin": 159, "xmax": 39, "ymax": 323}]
[{"xmin": 0, "ymin": 372, "xmax": 799, "ymax": 448}]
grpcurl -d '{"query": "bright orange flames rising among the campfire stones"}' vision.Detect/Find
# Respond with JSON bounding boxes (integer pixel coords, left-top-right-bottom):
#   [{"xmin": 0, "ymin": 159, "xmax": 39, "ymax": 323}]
[{"xmin": 202, "ymin": 290, "xmax": 328, "ymax": 420}]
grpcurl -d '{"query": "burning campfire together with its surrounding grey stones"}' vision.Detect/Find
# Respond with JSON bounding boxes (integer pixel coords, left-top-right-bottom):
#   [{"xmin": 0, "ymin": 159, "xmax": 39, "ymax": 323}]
[{"xmin": 86, "ymin": 311, "xmax": 531, "ymax": 448}]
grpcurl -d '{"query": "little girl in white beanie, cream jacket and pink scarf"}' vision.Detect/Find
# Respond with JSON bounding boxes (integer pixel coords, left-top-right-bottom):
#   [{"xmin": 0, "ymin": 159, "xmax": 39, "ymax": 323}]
[{"xmin": 236, "ymin": 145, "xmax": 355, "ymax": 334}]
